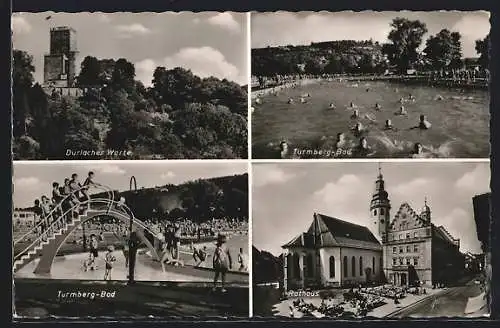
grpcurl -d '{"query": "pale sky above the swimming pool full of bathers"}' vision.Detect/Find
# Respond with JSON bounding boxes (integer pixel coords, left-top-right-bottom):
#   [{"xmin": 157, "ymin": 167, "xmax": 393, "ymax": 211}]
[{"xmin": 251, "ymin": 11, "xmax": 490, "ymax": 57}]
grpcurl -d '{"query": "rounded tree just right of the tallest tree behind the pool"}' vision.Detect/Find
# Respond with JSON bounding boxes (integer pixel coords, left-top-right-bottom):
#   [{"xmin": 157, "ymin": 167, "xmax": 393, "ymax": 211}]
[{"xmin": 424, "ymin": 29, "xmax": 462, "ymax": 70}]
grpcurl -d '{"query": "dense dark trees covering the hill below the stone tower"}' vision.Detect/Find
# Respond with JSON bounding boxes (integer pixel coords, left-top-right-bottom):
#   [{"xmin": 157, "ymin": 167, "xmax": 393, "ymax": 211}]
[{"xmin": 13, "ymin": 50, "xmax": 247, "ymax": 159}]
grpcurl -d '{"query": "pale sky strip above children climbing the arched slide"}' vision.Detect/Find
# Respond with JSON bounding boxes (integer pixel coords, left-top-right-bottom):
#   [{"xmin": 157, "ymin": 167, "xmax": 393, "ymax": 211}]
[{"xmin": 13, "ymin": 161, "xmax": 248, "ymax": 207}]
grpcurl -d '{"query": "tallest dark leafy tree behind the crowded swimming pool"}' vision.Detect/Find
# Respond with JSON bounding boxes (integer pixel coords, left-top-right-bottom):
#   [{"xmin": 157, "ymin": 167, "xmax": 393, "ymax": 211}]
[{"xmin": 383, "ymin": 17, "xmax": 427, "ymax": 73}]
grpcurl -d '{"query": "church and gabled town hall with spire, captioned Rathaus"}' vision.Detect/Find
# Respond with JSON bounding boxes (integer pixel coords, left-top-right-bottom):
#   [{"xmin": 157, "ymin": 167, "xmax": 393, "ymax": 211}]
[{"xmin": 282, "ymin": 169, "xmax": 465, "ymax": 290}]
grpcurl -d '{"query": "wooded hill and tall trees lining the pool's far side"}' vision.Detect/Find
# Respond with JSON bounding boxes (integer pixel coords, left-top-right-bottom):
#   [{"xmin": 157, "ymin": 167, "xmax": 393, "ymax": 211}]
[{"xmin": 252, "ymin": 18, "xmax": 489, "ymax": 76}]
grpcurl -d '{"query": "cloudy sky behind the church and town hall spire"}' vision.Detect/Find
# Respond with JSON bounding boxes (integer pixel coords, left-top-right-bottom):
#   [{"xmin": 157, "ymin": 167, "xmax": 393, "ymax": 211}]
[{"xmin": 252, "ymin": 162, "xmax": 490, "ymax": 255}]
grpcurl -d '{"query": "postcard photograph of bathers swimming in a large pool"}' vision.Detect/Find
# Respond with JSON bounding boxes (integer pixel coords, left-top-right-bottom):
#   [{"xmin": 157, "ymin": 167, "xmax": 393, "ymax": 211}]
[{"xmin": 251, "ymin": 11, "xmax": 490, "ymax": 159}]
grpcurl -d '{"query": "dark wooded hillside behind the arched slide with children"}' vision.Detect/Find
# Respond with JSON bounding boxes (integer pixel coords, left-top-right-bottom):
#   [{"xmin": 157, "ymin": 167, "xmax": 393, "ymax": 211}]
[{"xmin": 92, "ymin": 174, "xmax": 248, "ymax": 221}]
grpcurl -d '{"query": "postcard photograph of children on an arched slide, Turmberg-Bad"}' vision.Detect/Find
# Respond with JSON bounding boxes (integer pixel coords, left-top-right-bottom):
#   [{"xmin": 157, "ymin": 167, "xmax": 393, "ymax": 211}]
[{"xmin": 12, "ymin": 160, "xmax": 249, "ymax": 318}]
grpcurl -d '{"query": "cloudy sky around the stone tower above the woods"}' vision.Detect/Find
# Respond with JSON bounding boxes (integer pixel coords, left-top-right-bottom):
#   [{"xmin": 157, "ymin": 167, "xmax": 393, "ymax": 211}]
[{"xmin": 12, "ymin": 12, "xmax": 249, "ymax": 86}]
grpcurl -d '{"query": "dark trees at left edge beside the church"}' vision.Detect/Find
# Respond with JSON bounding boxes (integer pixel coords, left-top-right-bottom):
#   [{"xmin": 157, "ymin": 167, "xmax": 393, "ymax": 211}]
[{"xmin": 252, "ymin": 246, "xmax": 283, "ymax": 283}]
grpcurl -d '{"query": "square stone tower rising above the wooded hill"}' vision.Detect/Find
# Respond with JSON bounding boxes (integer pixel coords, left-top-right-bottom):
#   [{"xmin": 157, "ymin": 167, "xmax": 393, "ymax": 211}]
[{"xmin": 44, "ymin": 26, "xmax": 78, "ymax": 88}]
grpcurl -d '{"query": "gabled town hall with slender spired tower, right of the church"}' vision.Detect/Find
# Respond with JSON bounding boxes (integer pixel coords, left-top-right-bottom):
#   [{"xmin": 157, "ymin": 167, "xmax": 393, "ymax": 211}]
[{"xmin": 370, "ymin": 168, "xmax": 465, "ymax": 286}]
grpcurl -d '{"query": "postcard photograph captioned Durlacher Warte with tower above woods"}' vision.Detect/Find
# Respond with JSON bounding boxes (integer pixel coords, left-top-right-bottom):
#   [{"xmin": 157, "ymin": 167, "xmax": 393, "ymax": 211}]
[{"xmin": 12, "ymin": 12, "xmax": 249, "ymax": 160}]
